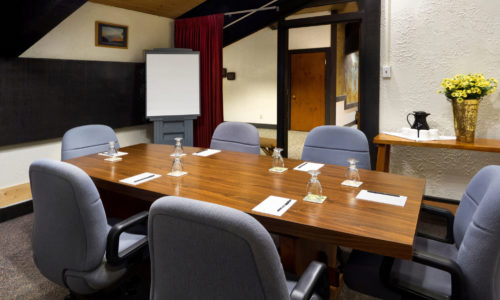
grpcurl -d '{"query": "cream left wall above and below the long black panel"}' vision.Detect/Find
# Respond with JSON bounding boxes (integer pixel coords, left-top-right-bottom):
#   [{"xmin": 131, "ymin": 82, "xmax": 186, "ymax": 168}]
[{"xmin": 0, "ymin": 2, "xmax": 173, "ymax": 189}]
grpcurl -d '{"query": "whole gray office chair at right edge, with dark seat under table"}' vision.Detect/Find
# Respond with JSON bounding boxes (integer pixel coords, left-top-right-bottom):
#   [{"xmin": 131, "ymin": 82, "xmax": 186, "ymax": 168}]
[{"xmin": 344, "ymin": 166, "xmax": 500, "ymax": 300}]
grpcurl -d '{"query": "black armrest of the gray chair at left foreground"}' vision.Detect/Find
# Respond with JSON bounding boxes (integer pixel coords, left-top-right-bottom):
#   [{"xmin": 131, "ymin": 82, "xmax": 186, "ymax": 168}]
[{"xmin": 106, "ymin": 211, "xmax": 149, "ymax": 266}]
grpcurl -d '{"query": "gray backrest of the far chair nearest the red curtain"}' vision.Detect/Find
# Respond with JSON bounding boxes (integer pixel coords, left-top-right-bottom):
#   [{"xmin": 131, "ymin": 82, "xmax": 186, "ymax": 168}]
[{"xmin": 210, "ymin": 122, "xmax": 260, "ymax": 154}]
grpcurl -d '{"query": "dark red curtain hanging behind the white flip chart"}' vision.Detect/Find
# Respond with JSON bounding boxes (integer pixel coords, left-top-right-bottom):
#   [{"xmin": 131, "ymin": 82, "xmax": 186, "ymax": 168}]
[{"xmin": 175, "ymin": 14, "xmax": 224, "ymax": 148}]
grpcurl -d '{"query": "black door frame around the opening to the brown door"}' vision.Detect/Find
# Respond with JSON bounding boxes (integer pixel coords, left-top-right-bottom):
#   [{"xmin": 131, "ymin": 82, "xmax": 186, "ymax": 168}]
[{"xmin": 277, "ymin": 0, "xmax": 381, "ymax": 169}]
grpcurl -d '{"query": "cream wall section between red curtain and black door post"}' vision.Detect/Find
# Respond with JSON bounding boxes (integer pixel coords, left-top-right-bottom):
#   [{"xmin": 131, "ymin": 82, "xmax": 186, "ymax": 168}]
[{"xmin": 222, "ymin": 27, "xmax": 278, "ymax": 124}]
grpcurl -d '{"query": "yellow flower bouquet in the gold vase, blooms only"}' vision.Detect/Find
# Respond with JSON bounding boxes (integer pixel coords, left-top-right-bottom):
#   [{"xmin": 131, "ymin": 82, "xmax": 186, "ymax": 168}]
[{"xmin": 438, "ymin": 73, "xmax": 498, "ymax": 103}]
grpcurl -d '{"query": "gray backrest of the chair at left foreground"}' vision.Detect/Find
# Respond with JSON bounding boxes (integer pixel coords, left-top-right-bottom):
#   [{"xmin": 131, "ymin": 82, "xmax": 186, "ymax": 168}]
[{"xmin": 29, "ymin": 159, "xmax": 108, "ymax": 286}]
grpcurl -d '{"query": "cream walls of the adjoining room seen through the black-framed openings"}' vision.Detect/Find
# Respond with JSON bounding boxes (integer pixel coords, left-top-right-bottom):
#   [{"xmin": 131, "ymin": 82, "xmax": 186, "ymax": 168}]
[{"xmin": 223, "ymin": 12, "xmax": 356, "ymax": 125}]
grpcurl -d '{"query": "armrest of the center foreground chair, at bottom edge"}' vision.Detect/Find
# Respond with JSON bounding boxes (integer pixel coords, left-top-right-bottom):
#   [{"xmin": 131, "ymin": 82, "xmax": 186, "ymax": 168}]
[{"xmin": 290, "ymin": 261, "xmax": 330, "ymax": 300}]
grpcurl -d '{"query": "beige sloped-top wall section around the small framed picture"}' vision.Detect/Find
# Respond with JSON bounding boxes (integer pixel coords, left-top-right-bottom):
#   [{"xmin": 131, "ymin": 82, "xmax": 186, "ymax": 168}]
[{"xmin": 20, "ymin": 2, "xmax": 174, "ymax": 62}]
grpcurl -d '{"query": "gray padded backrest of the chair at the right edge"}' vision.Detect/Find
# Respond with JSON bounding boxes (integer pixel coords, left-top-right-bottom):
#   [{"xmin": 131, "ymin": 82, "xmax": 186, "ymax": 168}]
[{"xmin": 454, "ymin": 166, "xmax": 500, "ymax": 300}]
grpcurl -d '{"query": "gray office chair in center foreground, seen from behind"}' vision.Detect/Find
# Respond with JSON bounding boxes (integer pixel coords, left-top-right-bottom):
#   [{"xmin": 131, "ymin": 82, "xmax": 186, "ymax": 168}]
[{"xmin": 148, "ymin": 197, "xmax": 329, "ymax": 300}]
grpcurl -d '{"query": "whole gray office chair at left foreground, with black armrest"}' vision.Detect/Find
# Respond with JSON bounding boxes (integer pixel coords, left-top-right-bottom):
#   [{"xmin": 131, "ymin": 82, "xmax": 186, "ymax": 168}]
[{"xmin": 29, "ymin": 159, "xmax": 148, "ymax": 295}]
